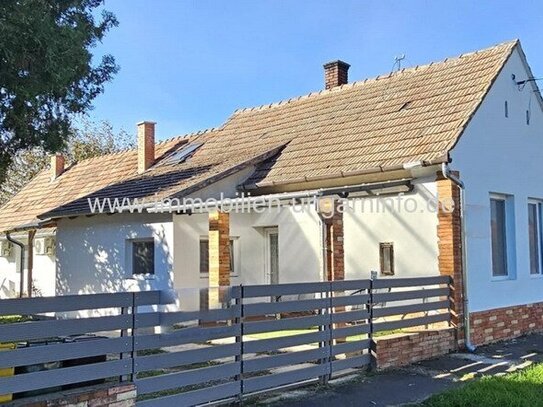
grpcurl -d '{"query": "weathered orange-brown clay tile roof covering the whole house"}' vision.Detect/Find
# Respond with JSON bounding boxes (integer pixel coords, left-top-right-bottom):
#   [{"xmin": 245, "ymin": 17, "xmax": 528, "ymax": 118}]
[{"xmin": 0, "ymin": 41, "xmax": 518, "ymax": 231}]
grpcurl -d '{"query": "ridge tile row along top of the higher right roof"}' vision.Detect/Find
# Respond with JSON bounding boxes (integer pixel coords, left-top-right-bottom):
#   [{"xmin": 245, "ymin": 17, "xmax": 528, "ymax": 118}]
[{"xmin": 232, "ymin": 38, "xmax": 520, "ymax": 116}]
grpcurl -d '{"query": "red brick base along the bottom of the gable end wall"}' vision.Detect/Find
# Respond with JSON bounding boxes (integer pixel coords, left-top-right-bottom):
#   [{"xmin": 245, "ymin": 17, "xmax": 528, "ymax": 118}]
[{"xmin": 470, "ymin": 302, "xmax": 543, "ymax": 345}]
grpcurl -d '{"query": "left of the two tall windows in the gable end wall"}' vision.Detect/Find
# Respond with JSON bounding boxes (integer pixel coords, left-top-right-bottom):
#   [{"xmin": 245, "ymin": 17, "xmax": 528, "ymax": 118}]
[{"xmin": 490, "ymin": 197, "xmax": 508, "ymax": 277}]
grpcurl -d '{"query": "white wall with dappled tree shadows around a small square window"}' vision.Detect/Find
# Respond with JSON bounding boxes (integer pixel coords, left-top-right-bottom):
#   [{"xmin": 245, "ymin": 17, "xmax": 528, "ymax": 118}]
[{"xmin": 56, "ymin": 214, "xmax": 173, "ymax": 295}]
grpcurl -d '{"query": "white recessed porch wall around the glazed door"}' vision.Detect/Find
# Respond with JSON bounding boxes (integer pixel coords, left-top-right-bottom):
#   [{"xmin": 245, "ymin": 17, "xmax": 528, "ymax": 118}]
[{"xmin": 174, "ymin": 207, "xmax": 322, "ymax": 309}]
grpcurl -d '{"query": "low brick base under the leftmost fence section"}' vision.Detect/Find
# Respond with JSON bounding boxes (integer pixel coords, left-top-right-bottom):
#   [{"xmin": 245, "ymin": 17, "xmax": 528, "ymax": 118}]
[{"xmin": 9, "ymin": 383, "xmax": 136, "ymax": 407}]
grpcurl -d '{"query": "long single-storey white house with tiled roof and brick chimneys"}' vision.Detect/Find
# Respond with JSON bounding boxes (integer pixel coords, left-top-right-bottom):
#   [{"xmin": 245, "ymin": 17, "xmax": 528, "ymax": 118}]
[{"xmin": 0, "ymin": 41, "xmax": 543, "ymax": 345}]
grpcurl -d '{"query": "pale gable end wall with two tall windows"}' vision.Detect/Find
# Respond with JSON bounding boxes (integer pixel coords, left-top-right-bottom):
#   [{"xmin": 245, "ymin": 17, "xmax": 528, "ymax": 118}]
[{"xmin": 451, "ymin": 47, "xmax": 543, "ymax": 312}]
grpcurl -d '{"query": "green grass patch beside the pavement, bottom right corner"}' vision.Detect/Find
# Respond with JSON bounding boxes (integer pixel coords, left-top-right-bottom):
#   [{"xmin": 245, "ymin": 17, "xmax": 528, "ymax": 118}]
[{"xmin": 421, "ymin": 364, "xmax": 543, "ymax": 407}]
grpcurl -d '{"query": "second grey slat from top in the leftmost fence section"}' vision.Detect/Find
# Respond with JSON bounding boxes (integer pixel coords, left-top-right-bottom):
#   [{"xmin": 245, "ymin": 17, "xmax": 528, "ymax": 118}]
[{"xmin": 0, "ymin": 315, "xmax": 132, "ymax": 342}]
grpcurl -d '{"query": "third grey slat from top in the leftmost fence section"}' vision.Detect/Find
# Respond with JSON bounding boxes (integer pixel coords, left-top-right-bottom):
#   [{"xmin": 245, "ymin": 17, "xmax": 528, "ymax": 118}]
[{"xmin": 0, "ymin": 337, "xmax": 132, "ymax": 370}]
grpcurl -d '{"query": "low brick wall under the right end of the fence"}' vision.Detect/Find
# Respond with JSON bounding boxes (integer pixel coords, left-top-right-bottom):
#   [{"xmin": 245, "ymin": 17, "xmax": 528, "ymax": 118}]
[{"xmin": 372, "ymin": 328, "xmax": 457, "ymax": 370}]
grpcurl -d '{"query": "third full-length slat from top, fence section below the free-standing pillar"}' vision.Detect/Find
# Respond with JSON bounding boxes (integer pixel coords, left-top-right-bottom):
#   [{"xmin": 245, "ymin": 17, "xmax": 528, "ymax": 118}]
[{"xmin": 134, "ymin": 343, "xmax": 241, "ymax": 373}]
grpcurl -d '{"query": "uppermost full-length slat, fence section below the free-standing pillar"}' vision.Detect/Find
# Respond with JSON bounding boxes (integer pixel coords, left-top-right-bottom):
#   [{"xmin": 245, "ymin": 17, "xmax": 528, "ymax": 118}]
[{"xmin": 136, "ymin": 305, "xmax": 241, "ymax": 328}]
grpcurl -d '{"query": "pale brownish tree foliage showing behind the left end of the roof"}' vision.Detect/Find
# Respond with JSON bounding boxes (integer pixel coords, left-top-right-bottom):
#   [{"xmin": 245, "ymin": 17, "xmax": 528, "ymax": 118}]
[{"xmin": 0, "ymin": 119, "xmax": 135, "ymax": 206}]
